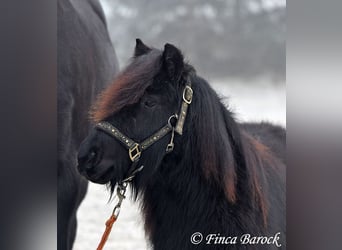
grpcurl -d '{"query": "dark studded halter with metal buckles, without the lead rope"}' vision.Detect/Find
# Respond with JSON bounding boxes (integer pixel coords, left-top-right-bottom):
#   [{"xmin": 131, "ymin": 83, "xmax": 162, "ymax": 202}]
[{"xmin": 96, "ymin": 80, "xmax": 193, "ymax": 182}]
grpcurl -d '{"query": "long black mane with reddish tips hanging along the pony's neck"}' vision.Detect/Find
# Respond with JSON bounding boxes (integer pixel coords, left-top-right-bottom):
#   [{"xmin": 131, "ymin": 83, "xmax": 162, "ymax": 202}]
[{"xmin": 188, "ymin": 76, "xmax": 273, "ymax": 225}]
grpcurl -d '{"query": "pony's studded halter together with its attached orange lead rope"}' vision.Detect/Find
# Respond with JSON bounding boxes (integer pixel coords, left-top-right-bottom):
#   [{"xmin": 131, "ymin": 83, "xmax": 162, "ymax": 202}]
[{"xmin": 96, "ymin": 77, "xmax": 193, "ymax": 250}]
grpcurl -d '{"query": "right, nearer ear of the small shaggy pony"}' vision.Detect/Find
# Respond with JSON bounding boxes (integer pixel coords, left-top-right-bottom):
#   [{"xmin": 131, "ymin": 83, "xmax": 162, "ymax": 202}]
[{"xmin": 163, "ymin": 43, "xmax": 184, "ymax": 81}]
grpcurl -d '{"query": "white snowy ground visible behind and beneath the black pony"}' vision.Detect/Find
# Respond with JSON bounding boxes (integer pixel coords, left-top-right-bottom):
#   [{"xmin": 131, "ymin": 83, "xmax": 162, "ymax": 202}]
[{"xmin": 74, "ymin": 80, "xmax": 286, "ymax": 250}]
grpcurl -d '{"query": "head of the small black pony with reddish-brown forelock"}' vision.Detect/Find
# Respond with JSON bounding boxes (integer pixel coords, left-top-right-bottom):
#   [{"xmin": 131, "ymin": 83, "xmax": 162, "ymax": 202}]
[{"xmin": 78, "ymin": 39, "xmax": 192, "ymax": 190}]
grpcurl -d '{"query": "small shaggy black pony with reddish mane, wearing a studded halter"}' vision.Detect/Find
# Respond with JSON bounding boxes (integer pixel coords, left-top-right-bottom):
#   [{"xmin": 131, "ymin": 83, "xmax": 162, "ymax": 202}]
[{"xmin": 78, "ymin": 39, "xmax": 286, "ymax": 250}]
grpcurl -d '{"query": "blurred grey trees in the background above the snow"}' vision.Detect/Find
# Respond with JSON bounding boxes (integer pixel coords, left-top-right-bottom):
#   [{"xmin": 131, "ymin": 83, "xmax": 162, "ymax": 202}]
[{"xmin": 102, "ymin": 0, "xmax": 286, "ymax": 82}]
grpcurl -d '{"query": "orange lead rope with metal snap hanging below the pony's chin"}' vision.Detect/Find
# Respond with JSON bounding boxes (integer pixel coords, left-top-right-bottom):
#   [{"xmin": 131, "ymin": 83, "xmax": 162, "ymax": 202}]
[{"xmin": 96, "ymin": 181, "xmax": 128, "ymax": 250}]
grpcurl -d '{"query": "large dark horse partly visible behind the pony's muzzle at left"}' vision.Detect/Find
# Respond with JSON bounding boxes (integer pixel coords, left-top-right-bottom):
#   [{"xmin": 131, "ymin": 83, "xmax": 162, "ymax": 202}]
[{"xmin": 57, "ymin": 0, "xmax": 118, "ymax": 250}]
